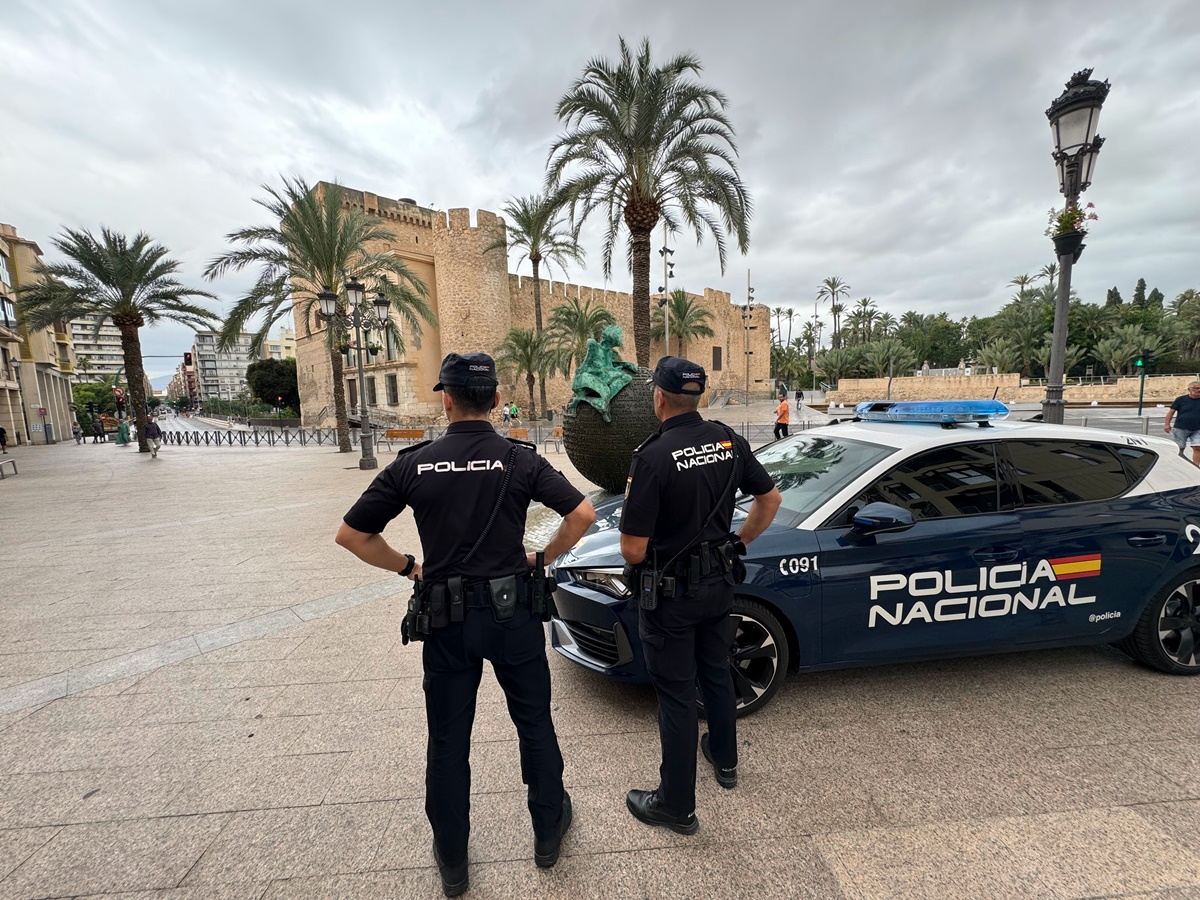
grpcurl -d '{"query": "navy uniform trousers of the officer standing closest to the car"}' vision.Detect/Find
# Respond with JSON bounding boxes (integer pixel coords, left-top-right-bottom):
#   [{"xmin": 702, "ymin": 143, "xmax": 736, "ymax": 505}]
[{"xmin": 637, "ymin": 577, "xmax": 738, "ymax": 815}]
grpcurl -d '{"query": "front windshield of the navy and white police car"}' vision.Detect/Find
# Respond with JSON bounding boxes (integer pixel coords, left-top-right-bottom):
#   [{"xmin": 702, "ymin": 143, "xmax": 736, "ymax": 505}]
[{"xmin": 739, "ymin": 434, "xmax": 895, "ymax": 515}]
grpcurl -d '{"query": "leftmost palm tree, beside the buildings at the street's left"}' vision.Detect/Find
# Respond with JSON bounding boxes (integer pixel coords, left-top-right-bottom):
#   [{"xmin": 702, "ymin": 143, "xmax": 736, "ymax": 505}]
[{"xmin": 18, "ymin": 228, "xmax": 216, "ymax": 454}]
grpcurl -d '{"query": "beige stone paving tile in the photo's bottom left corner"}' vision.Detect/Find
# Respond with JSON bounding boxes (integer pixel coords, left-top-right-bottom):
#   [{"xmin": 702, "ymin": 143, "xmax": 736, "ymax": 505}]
[{"xmin": 2, "ymin": 816, "xmax": 229, "ymax": 896}]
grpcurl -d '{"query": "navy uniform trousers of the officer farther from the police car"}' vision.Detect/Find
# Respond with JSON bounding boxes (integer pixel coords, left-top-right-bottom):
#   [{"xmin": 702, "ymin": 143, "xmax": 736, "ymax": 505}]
[{"xmin": 421, "ymin": 604, "xmax": 563, "ymax": 865}]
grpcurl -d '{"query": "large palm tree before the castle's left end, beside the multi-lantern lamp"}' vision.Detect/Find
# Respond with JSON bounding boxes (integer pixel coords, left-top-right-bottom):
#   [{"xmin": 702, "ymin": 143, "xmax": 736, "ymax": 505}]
[{"xmin": 204, "ymin": 178, "xmax": 437, "ymax": 452}]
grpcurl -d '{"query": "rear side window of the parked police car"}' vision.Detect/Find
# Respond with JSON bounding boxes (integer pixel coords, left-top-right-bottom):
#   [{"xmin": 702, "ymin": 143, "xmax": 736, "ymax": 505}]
[{"xmin": 1004, "ymin": 440, "xmax": 1129, "ymax": 506}]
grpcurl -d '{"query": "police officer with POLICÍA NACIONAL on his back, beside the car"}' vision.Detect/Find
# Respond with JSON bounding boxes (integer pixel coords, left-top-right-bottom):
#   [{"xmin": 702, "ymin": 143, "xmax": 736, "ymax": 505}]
[{"xmin": 620, "ymin": 356, "xmax": 781, "ymax": 834}]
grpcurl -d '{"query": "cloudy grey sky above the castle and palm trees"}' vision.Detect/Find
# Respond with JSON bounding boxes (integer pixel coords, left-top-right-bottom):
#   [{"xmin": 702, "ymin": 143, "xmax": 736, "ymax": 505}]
[{"xmin": 0, "ymin": 0, "xmax": 1200, "ymax": 374}]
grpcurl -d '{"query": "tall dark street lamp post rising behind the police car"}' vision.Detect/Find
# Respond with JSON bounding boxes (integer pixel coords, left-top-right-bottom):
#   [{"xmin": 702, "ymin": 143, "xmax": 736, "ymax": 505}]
[{"xmin": 1042, "ymin": 68, "xmax": 1110, "ymax": 425}]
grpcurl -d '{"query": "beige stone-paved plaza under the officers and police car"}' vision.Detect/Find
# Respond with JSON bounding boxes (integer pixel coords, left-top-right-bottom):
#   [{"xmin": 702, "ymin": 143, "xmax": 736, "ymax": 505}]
[{"xmin": 0, "ymin": 443, "xmax": 1200, "ymax": 900}]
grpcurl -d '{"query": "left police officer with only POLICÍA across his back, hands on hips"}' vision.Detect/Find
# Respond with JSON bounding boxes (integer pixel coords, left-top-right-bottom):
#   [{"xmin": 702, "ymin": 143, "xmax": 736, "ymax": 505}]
[{"xmin": 336, "ymin": 353, "xmax": 595, "ymax": 896}]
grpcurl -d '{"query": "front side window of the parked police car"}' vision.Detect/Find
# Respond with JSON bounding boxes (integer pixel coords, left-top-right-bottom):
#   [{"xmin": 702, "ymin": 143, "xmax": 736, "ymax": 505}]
[{"xmin": 832, "ymin": 443, "xmax": 1000, "ymax": 524}]
